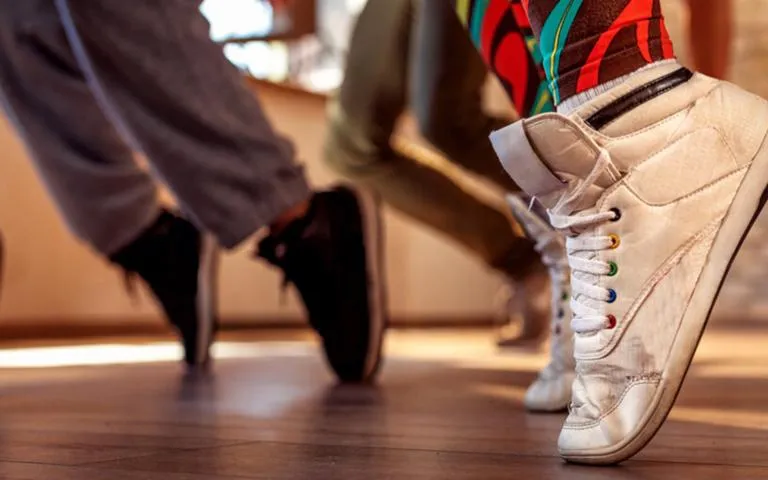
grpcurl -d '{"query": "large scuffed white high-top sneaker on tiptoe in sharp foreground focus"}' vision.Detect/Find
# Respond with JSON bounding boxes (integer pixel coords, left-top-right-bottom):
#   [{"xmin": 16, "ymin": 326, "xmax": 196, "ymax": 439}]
[{"xmin": 492, "ymin": 63, "xmax": 768, "ymax": 464}]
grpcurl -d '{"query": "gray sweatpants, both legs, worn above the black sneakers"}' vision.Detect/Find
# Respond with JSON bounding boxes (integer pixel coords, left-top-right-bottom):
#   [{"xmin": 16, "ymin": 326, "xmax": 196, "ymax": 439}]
[{"xmin": 0, "ymin": 0, "xmax": 310, "ymax": 255}]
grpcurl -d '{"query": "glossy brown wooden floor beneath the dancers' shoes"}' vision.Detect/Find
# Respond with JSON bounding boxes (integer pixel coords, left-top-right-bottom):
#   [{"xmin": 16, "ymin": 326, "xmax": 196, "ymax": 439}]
[{"xmin": 0, "ymin": 329, "xmax": 768, "ymax": 480}]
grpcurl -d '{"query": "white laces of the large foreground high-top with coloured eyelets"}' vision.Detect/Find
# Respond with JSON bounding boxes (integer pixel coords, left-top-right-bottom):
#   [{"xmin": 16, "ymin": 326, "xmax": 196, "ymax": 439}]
[{"xmin": 549, "ymin": 149, "xmax": 619, "ymax": 334}]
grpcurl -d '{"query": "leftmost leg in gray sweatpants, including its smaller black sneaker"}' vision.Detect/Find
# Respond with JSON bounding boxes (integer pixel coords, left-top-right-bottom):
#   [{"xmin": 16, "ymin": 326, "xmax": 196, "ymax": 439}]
[{"xmin": 0, "ymin": 0, "xmax": 216, "ymax": 366}]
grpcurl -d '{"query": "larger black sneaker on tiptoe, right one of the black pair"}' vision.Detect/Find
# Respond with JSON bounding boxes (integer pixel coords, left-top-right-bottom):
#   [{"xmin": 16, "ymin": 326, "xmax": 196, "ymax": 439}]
[{"xmin": 258, "ymin": 187, "xmax": 387, "ymax": 382}]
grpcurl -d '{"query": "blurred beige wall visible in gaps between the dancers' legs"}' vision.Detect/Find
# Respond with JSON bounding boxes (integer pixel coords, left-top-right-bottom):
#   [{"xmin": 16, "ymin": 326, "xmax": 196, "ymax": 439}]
[{"xmin": 0, "ymin": 0, "xmax": 768, "ymax": 330}]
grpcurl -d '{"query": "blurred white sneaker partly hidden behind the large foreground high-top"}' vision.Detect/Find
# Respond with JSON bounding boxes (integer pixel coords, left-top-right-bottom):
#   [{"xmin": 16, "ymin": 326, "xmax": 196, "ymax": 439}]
[{"xmin": 507, "ymin": 195, "xmax": 576, "ymax": 412}]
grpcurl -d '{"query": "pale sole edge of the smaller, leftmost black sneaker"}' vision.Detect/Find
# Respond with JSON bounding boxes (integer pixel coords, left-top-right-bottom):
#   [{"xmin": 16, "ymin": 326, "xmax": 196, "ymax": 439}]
[{"xmin": 195, "ymin": 233, "xmax": 221, "ymax": 365}]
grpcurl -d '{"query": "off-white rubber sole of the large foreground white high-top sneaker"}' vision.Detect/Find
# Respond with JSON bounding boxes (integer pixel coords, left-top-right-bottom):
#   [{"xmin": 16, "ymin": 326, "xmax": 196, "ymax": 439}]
[{"xmin": 560, "ymin": 129, "xmax": 768, "ymax": 465}]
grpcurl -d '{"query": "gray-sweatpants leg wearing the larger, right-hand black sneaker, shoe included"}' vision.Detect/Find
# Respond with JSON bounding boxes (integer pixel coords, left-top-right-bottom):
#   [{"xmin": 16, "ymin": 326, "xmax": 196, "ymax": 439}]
[{"xmin": 56, "ymin": 0, "xmax": 386, "ymax": 381}]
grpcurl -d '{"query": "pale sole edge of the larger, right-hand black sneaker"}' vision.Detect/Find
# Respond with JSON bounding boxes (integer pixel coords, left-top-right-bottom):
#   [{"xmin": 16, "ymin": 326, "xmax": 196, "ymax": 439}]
[{"xmin": 347, "ymin": 187, "xmax": 388, "ymax": 381}]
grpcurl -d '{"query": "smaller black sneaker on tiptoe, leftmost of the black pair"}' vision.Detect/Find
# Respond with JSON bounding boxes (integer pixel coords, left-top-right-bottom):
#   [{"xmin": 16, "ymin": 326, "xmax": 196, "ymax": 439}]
[{"xmin": 110, "ymin": 212, "xmax": 219, "ymax": 370}]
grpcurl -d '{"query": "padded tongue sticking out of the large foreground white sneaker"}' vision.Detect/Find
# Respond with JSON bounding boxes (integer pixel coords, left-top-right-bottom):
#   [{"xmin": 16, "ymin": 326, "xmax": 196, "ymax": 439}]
[{"xmin": 491, "ymin": 114, "xmax": 619, "ymax": 210}]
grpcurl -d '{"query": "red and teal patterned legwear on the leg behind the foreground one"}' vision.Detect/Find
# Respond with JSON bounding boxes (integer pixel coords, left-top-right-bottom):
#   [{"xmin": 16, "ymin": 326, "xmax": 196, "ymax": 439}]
[{"xmin": 452, "ymin": 0, "xmax": 554, "ymax": 117}]
